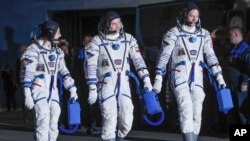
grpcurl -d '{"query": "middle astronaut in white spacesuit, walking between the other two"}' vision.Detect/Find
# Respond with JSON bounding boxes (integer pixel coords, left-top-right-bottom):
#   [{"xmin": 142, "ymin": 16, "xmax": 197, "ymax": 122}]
[{"xmin": 85, "ymin": 11, "xmax": 152, "ymax": 141}]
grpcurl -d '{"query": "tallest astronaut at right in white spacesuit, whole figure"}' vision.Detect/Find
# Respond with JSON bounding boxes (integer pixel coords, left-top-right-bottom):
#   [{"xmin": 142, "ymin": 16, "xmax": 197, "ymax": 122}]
[{"xmin": 153, "ymin": 2, "xmax": 226, "ymax": 141}]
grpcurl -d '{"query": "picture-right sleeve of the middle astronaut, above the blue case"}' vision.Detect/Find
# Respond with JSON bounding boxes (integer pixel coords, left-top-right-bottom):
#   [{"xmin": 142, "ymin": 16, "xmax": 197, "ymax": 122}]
[{"xmin": 127, "ymin": 34, "xmax": 149, "ymax": 80}]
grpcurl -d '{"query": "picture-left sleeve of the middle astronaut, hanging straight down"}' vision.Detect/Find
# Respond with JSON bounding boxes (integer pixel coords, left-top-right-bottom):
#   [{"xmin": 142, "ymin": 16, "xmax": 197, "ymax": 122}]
[{"xmin": 84, "ymin": 39, "xmax": 99, "ymax": 85}]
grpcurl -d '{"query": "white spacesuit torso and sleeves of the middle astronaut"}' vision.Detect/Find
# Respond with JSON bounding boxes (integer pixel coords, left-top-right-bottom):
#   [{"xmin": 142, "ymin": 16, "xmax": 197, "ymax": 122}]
[{"xmin": 85, "ymin": 33, "xmax": 148, "ymax": 99}]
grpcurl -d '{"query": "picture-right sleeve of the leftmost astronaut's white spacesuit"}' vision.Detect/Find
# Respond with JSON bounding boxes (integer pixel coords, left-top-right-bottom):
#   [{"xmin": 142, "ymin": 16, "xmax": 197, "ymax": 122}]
[{"xmin": 58, "ymin": 49, "xmax": 75, "ymax": 90}]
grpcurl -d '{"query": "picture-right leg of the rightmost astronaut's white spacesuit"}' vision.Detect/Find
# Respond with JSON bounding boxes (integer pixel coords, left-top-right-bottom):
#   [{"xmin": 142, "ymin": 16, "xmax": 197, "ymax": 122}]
[{"xmin": 192, "ymin": 86, "xmax": 205, "ymax": 135}]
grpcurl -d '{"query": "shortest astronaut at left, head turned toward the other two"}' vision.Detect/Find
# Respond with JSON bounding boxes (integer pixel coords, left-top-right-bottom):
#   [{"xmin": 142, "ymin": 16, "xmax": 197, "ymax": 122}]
[{"xmin": 21, "ymin": 21, "xmax": 78, "ymax": 141}]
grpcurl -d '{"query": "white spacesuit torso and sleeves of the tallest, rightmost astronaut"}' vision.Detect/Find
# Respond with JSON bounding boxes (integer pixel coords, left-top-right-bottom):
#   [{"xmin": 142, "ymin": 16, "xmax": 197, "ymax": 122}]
[{"xmin": 157, "ymin": 27, "xmax": 218, "ymax": 89}]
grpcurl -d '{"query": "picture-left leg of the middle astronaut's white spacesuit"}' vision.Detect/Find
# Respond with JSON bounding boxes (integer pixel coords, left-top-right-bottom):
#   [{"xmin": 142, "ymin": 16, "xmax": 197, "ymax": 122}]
[{"xmin": 98, "ymin": 77, "xmax": 117, "ymax": 140}]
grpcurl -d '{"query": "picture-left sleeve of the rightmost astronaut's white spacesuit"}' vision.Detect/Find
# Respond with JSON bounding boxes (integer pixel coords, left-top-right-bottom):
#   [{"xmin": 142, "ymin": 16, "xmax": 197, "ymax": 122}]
[{"xmin": 155, "ymin": 29, "xmax": 177, "ymax": 75}]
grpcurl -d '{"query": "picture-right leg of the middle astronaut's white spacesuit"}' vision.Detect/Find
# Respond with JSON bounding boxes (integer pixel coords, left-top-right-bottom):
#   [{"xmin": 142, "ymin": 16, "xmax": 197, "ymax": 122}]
[{"xmin": 117, "ymin": 81, "xmax": 134, "ymax": 140}]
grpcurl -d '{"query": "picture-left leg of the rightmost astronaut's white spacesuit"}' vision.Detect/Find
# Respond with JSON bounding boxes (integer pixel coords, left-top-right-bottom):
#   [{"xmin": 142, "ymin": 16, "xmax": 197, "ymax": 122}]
[{"xmin": 175, "ymin": 83, "xmax": 194, "ymax": 134}]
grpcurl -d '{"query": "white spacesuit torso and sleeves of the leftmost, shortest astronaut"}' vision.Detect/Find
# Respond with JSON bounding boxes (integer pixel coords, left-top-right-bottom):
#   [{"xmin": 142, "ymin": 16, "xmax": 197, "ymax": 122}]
[{"xmin": 21, "ymin": 41, "xmax": 74, "ymax": 103}]
